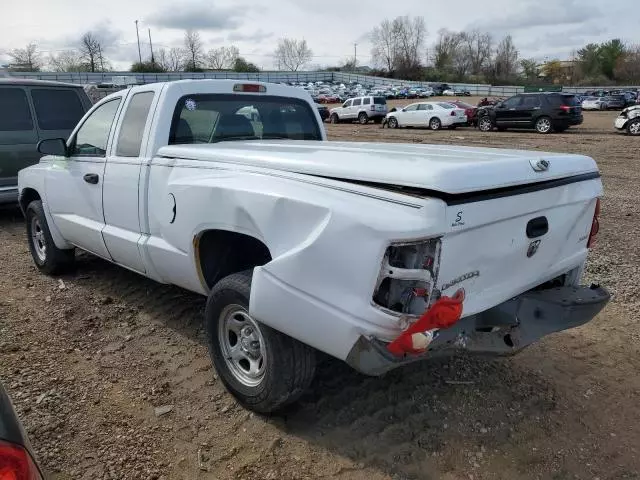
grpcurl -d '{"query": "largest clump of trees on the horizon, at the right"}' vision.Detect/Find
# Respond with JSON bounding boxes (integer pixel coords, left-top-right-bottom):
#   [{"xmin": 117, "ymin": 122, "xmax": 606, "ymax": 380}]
[{"xmin": 371, "ymin": 16, "xmax": 640, "ymax": 85}]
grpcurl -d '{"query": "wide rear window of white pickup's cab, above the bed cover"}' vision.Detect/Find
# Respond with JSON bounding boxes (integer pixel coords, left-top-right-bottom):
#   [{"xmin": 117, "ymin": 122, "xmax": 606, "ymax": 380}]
[{"xmin": 169, "ymin": 94, "xmax": 322, "ymax": 145}]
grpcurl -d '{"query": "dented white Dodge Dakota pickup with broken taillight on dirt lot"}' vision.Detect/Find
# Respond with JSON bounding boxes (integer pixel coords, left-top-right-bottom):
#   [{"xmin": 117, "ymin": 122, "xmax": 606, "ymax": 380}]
[{"xmin": 19, "ymin": 80, "xmax": 609, "ymax": 412}]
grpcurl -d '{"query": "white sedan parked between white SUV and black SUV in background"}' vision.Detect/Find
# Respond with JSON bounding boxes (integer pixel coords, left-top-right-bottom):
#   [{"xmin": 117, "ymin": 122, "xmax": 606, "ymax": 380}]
[{"xmin": 387, "ymin": 102, "xmax": 467, "ymax": 130}]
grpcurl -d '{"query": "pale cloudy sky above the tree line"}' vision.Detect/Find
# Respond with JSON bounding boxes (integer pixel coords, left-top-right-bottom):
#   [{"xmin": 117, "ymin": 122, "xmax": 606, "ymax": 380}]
[{"xmin": 0, "ymin": 0, "xmax": 640, "ymax": 70}]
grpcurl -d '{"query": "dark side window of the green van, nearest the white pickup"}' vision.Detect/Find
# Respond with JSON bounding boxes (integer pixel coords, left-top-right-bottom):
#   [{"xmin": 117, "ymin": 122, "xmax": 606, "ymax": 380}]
[{"xmin": 31, "ymin": 88, "xmax": 85, "ymax": 131}]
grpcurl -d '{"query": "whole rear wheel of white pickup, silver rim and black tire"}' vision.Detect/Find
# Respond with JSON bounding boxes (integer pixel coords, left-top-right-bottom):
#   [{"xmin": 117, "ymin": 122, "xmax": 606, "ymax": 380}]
[{"xmin": 205, "ymin": 270, "xmax": 316, "ymax": 413}]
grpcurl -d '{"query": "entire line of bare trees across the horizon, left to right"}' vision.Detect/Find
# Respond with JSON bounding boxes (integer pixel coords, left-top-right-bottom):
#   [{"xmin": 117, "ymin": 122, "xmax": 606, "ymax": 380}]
[{"xmin": 8, "ymin": 16, "xmax": 640, "ymax": 85}]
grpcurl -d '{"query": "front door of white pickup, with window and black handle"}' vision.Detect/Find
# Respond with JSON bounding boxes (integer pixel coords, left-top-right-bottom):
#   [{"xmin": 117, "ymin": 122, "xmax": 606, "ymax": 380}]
[{"xmin": 45, "ymin": 96, "xmax": 123, "ymax": 260}]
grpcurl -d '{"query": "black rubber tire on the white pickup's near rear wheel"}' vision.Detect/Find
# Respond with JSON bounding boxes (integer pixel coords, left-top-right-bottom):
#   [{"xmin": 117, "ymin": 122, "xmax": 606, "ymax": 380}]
[{"xmin": 205, "ymin": 270, "xmax": 316, "ymax": 413}]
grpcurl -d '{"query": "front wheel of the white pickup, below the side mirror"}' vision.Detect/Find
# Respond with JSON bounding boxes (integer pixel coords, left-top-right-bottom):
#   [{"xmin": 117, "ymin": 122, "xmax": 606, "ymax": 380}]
[{"xmin": 25, "ymin": 200, "xmax": 76, "ymax": 275}]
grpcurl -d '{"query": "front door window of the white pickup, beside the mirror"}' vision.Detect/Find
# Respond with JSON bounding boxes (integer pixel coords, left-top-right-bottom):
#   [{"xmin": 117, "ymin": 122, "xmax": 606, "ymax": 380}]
[{"xmin": 71, "ymin": 98, "xmax": 122, "ymax": 157}]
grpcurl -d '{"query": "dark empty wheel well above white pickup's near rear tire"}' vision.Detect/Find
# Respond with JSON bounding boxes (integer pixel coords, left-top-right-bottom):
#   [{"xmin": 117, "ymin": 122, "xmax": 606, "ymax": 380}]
[{"xmin": 195, "ymin": 230, "xmax": 271, "ymax": 288}]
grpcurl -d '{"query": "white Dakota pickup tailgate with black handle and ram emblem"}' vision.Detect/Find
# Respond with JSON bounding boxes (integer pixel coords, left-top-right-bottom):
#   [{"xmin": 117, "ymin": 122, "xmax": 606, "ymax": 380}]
[{"xmin": 437, "ymin": 178, "xmax": 602, "ymax": 316}]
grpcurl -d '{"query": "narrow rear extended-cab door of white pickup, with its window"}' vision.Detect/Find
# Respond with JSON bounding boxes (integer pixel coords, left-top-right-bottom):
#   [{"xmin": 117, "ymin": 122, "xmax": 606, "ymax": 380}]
[{"xmin": 102, "ymin": 87, "xmax": 157, "ymax": 274}]
